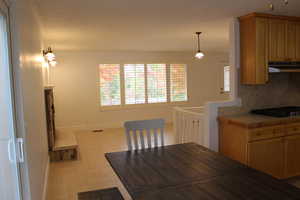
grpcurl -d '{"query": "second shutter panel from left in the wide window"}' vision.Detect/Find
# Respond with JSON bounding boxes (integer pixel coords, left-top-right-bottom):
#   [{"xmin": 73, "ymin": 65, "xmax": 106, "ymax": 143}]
[{"xmin": 124, "ymin": 64, "xmax": 145, "ymax": 104}]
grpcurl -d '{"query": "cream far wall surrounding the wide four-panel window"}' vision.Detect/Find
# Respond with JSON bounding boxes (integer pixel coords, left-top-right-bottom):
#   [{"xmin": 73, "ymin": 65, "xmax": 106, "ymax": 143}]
[{"xmin": 51, "ymin": 51, "xmax": 228, "ymax": 129}]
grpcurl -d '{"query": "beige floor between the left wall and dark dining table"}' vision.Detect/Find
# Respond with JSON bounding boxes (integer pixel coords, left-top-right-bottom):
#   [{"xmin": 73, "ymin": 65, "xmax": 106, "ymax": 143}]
[{"xmin": 47, "ymin": 125, "xmax": 175, "ymax": 200}]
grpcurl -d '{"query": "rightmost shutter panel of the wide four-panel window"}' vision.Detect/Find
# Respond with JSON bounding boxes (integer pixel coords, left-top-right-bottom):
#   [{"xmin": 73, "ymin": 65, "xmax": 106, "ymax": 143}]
[{"xmin": 170, "ymin": 64, "xmax": 187, "ymax": 102}]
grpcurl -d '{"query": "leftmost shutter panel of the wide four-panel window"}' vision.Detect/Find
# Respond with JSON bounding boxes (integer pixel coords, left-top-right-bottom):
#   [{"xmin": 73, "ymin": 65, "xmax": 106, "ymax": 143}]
[{"xmin": 99, "ymin": 64, "xmax": 121, "ymax": 106}]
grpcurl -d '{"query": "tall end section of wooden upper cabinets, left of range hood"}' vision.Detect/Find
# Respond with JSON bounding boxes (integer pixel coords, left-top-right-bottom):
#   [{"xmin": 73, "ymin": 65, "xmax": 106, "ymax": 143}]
[{"xmin": 240, "ymin": 15, "xmax": 269, "ymax": 84}]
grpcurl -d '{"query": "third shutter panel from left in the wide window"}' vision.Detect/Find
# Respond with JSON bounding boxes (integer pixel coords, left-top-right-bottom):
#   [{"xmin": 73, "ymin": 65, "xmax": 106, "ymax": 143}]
[{"xmin": 147, "ymin": 64, "xmax": 167, "ymax": 103}]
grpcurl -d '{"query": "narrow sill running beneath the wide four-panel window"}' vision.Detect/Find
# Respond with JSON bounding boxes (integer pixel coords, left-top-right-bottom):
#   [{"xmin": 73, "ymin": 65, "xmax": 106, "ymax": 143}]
[{"xmin": 99, "ymin": 101, "xmax": 189, "ymax": 112}]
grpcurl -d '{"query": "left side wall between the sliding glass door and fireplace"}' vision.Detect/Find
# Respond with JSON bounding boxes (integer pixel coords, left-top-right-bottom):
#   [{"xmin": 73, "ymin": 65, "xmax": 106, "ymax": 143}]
[{"xmin": 11, "ymin": 0, "xmax": 49, "ymax": 200}]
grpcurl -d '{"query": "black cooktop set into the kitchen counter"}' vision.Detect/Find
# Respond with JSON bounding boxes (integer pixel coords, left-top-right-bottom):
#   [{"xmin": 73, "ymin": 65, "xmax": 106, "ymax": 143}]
[{"xmin": 251, "ymin": 106, "xmax": 300, "ymax": 117}]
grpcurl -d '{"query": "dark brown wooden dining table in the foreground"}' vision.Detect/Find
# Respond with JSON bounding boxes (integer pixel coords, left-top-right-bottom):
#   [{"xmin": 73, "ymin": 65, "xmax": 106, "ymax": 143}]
[{"xmin": 105, "ymin": 143, "xmax": 300, "ymax": 200}]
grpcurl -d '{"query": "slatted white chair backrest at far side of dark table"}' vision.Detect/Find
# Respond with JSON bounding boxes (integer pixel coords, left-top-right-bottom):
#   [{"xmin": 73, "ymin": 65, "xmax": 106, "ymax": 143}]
[{"xmin": 124, "ymin": 119, "xmax": 165, "ymax": 151}]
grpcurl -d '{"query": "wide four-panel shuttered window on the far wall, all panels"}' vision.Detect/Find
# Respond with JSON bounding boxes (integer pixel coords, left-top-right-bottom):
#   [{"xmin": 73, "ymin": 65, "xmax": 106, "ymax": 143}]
[{"xmin": 99, "ymin": 64, "xmax": 188, "ymax": 106}]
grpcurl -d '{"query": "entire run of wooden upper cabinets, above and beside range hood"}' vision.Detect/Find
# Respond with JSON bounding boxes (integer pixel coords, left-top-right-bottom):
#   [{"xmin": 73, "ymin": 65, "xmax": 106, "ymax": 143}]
[{"xmin": 239, "ymin": 13, "xmax": 300, "ymax": 85}]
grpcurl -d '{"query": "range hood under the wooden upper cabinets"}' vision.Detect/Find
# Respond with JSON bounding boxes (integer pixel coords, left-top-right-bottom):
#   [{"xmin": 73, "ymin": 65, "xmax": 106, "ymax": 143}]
[{"xmin": 268, "ymin": 62, "xmax": 300, "ymax": 73}]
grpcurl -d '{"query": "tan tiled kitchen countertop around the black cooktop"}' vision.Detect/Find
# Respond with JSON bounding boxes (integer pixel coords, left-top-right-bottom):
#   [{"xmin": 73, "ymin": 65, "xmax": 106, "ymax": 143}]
[{"xmin": 218, "ymin": 114, "xmax": 300, "ymax": 128}]
